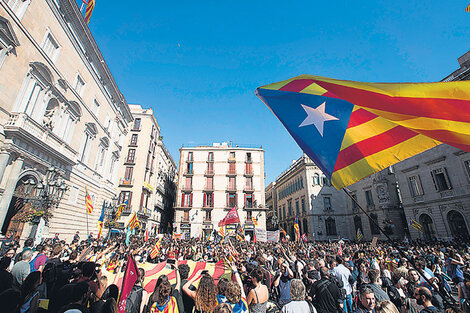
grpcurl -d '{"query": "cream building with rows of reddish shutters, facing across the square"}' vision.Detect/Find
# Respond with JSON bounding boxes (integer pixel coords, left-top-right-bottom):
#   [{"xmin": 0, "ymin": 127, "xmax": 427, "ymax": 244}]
[{"xmin": 174, "ymin": 143, "xmax": 266, "ymax": 238}]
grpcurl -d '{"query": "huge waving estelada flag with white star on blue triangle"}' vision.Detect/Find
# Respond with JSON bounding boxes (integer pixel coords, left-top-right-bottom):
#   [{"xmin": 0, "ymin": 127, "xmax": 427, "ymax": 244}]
[{"xmin": 256, "ymin": 75, "xmax": 470, "ymax": 189}]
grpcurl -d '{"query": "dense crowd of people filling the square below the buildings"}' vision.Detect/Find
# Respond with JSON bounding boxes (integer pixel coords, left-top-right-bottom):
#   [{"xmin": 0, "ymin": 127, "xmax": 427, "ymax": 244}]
[{"xmin": 0, "ymin": 232, "xmax": 470, "ymax": 313}]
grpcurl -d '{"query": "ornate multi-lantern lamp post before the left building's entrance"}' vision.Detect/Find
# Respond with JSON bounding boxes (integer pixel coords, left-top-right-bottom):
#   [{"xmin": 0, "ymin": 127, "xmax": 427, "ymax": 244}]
[{"xmin": 15, "ymin": 166, "xmax": 69, "ymax": 239}]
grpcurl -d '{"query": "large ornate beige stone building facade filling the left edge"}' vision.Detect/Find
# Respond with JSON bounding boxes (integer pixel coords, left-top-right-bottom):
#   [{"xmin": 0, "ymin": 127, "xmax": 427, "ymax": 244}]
[{"xmin": 0, "ymin": 0, "xmax": 132, "ymax": 238}]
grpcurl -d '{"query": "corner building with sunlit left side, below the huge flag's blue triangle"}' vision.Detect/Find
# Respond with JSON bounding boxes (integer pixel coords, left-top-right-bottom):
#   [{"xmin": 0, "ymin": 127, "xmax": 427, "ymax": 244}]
[{"xmin": 275, "ymin": 154, "xmax": 351, "ymax": 240}]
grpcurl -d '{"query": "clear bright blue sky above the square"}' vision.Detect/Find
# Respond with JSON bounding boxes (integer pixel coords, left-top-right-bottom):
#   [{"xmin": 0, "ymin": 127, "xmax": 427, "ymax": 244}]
[{"xmin": 83, "ymin": 0, "xmax": 470, "ymax": 185}]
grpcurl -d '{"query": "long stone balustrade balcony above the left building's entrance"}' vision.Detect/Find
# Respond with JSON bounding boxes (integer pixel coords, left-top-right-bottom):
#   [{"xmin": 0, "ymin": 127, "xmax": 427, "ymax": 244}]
[{"xmin": 5, "ymin": 113, "xmax": 77, "ymax": 165}]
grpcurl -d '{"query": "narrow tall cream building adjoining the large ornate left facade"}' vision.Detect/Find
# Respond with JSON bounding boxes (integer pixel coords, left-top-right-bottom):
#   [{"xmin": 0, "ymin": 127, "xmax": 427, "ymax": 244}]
[{"xmin": 118, "ymin": 105, "xmax": 161, "ymax": 234}]
